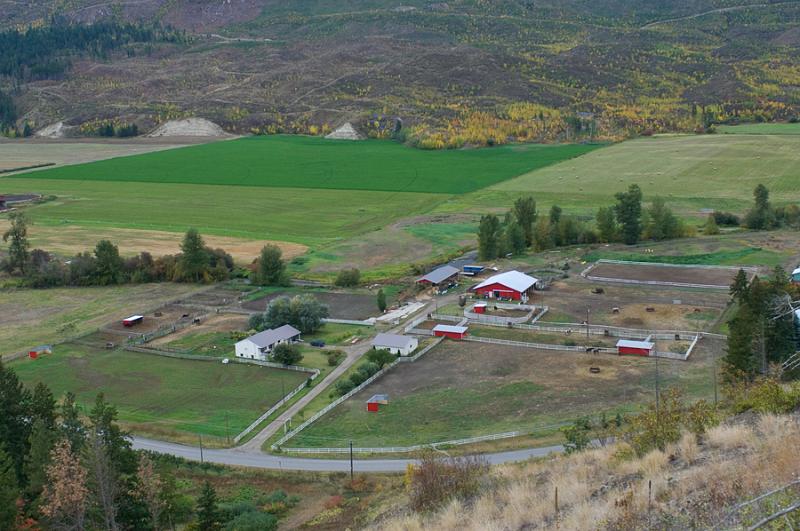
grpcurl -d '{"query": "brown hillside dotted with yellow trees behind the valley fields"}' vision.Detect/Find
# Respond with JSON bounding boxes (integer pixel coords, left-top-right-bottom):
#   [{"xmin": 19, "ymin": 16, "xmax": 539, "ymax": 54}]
[{"xmin": 0, "ymin": 0, "xmax": 800, "ymax": 143}]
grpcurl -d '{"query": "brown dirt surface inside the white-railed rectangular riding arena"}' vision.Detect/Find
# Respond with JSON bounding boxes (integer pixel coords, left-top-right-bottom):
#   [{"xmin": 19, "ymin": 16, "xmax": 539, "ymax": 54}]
[{"xmin": 588, "ymin": 262, "xmax": 737, "ymax": 288}]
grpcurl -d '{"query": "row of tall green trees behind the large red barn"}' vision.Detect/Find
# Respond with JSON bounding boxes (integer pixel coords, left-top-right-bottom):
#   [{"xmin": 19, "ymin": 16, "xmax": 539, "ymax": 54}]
[{"xmin": 478, "ymin": 184, "xmax": 687, "ymax": 260}]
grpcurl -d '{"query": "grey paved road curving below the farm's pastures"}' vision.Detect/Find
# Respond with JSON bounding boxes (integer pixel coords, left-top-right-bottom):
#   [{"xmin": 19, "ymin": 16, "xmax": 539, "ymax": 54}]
[{"xmin": 132, "ymin": 437, "xmax": 564, "ymax": 473}]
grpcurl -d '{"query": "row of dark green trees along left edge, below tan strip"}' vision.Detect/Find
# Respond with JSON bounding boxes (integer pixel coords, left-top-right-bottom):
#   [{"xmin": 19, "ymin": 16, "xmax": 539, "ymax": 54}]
[{"xmin": 0, "ymin": 212, "xmax": 234, "ymax": 288}]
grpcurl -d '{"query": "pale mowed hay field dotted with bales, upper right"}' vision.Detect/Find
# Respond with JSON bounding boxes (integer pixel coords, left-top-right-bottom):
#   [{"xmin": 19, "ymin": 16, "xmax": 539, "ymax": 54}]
[{"xmin": 484, "ymin": 135, "xmax": 800, "ymax": 213}]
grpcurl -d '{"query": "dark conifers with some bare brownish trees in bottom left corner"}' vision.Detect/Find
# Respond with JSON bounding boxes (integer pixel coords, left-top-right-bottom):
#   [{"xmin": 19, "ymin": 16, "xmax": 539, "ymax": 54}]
[{"xmin": 0, "ymin": 362, "xmax": 288, "ymax": 531}]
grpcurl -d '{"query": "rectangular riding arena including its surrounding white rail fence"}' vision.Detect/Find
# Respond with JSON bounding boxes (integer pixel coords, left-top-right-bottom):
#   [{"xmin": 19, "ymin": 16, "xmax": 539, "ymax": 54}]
[{"xmin": 581, "ymin": 260, "xmax": 755, "ymax": 289}]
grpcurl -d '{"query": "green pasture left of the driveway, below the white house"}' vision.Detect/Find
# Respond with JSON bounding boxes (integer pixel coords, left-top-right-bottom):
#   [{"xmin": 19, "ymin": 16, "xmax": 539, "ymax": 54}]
[{"xmin": 10, "ymin": 343, "xmax": 308, "ymax": 442}]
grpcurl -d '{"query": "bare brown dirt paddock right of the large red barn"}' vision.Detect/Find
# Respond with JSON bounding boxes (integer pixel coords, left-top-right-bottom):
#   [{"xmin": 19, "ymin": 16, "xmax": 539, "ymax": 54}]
[{"xmin": 533, "ymin": 277, "xmax": 729, "ymax": 331}]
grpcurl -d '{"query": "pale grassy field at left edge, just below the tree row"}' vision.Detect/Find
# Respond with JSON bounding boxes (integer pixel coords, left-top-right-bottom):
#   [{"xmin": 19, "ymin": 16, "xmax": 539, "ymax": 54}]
[{"xmin": 0, "ymin": 283, "xmax": 198, "ymax": 360}]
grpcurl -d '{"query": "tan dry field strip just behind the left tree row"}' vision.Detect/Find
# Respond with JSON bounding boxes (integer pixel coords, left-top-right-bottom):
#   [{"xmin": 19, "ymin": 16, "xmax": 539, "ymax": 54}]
[{"xmin": 0, "ymin": 219, "xmax": 308, "ymax": 265}]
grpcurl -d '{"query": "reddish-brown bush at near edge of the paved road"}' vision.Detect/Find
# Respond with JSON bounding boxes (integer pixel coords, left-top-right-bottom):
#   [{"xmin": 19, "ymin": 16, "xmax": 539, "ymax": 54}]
[{"xmin": 406, "ymin": 451, "xmax": 489, "ymax": 511}]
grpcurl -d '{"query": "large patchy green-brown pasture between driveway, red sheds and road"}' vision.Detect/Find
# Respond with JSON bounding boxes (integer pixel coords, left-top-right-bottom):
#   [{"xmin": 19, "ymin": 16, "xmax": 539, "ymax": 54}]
[{"xmin": 285, "ymin": 340, "xmax": 721, "ymax": 448}]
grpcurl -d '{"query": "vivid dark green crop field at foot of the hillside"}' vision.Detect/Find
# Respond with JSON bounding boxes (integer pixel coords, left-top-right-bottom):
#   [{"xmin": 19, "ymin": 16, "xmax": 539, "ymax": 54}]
[{"xmin": 7, "ymin": 136, "xmax": 600, "ymax": 194}]
